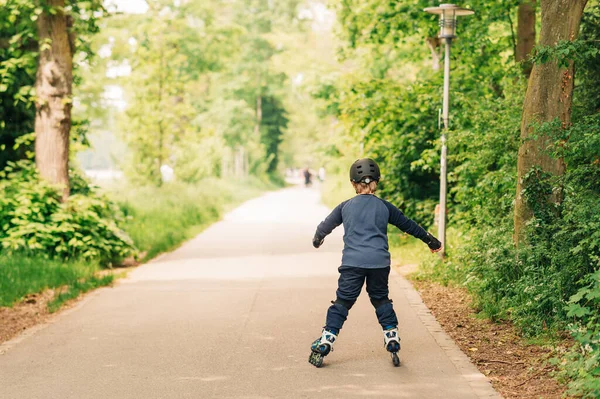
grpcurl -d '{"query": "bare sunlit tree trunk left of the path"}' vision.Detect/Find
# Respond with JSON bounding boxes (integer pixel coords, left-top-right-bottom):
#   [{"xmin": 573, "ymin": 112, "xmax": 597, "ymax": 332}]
[{"xmin": 35, "ymin": 0, "xmax": 73, "ymax": 199}]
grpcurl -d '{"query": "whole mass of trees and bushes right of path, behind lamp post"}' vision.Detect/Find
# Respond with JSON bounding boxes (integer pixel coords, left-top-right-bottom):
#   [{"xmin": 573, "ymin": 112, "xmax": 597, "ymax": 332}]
[{"xmin": 318, "ymin": 0, "xmax": 600, "ymax": 398}]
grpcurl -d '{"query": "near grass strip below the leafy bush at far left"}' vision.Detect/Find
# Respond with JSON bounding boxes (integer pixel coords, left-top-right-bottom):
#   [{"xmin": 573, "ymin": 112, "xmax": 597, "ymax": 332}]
[{"xmin": 0, "ymin": 254, "xmax": 112, "ymax": 306}]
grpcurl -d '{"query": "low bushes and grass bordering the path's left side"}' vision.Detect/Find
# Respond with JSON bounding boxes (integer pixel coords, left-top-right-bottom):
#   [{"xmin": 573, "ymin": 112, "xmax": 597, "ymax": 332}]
[{"xmin": 0, "ymin": 161, "xmax": 276, "ymax": 312}]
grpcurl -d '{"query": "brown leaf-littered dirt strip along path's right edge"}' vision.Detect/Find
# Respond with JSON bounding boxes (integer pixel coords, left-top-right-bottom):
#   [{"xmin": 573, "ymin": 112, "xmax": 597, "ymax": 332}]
[{"xmin": 400, "ymin": 276, "xmax": 566, "ymax": 399}]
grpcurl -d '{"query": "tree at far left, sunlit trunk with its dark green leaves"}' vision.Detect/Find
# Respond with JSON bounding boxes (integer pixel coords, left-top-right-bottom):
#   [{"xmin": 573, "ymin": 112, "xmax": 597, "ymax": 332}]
[{"xmin": 0, "ymin": 0, "xmax": 103, "ymax": 175}]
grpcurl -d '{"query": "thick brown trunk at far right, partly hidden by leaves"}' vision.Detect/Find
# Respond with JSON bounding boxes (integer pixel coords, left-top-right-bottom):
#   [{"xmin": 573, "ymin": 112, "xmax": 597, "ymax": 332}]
[{"xmin": 514, "ymin": 0, "xmax": 587, "ymax": 244}]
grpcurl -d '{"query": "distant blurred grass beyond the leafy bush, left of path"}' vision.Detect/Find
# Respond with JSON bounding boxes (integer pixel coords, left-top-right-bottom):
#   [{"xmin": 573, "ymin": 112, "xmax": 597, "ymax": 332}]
[{"xmin": 109, "ymin": 178, "xmax": 274, "ymax": 261}]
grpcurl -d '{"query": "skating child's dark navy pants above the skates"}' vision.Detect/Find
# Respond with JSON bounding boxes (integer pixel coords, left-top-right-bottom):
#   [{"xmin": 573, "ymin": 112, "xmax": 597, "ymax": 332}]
[{"xmin": 325, "ymin": 266, "xmax": 398, "ymax": 331}]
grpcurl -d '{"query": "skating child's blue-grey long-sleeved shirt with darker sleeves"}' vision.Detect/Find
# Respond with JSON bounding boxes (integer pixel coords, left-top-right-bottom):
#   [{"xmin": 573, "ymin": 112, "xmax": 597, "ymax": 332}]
[{"xmin": 315, "ymin": 194, "xmax": 428, "ymax": 269}]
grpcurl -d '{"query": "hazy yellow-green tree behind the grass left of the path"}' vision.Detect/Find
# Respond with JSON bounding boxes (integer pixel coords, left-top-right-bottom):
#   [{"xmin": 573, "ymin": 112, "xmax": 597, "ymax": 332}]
[{"xmin": 116, "ymin": 0, "xmax": 233, "ymax": 186}]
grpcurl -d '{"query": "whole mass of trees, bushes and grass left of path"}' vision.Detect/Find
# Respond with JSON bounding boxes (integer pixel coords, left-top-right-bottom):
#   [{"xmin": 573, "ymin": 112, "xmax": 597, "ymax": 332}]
[{"xmin": 0, "ymin": 0, "xmax": 294, "ymax": 311}]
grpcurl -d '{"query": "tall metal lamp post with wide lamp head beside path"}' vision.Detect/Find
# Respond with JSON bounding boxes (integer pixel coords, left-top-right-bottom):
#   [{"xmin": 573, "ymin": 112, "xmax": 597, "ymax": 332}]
[{"xmin": 425, "ymin": 4, "xmax": 475, "ymax": 257}]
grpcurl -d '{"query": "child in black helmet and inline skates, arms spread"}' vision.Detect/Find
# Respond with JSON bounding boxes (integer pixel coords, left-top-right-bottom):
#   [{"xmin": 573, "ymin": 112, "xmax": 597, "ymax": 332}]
[{"xmin": 308, "ymin": 158, "xmax": 442, "ymax": 367}]
